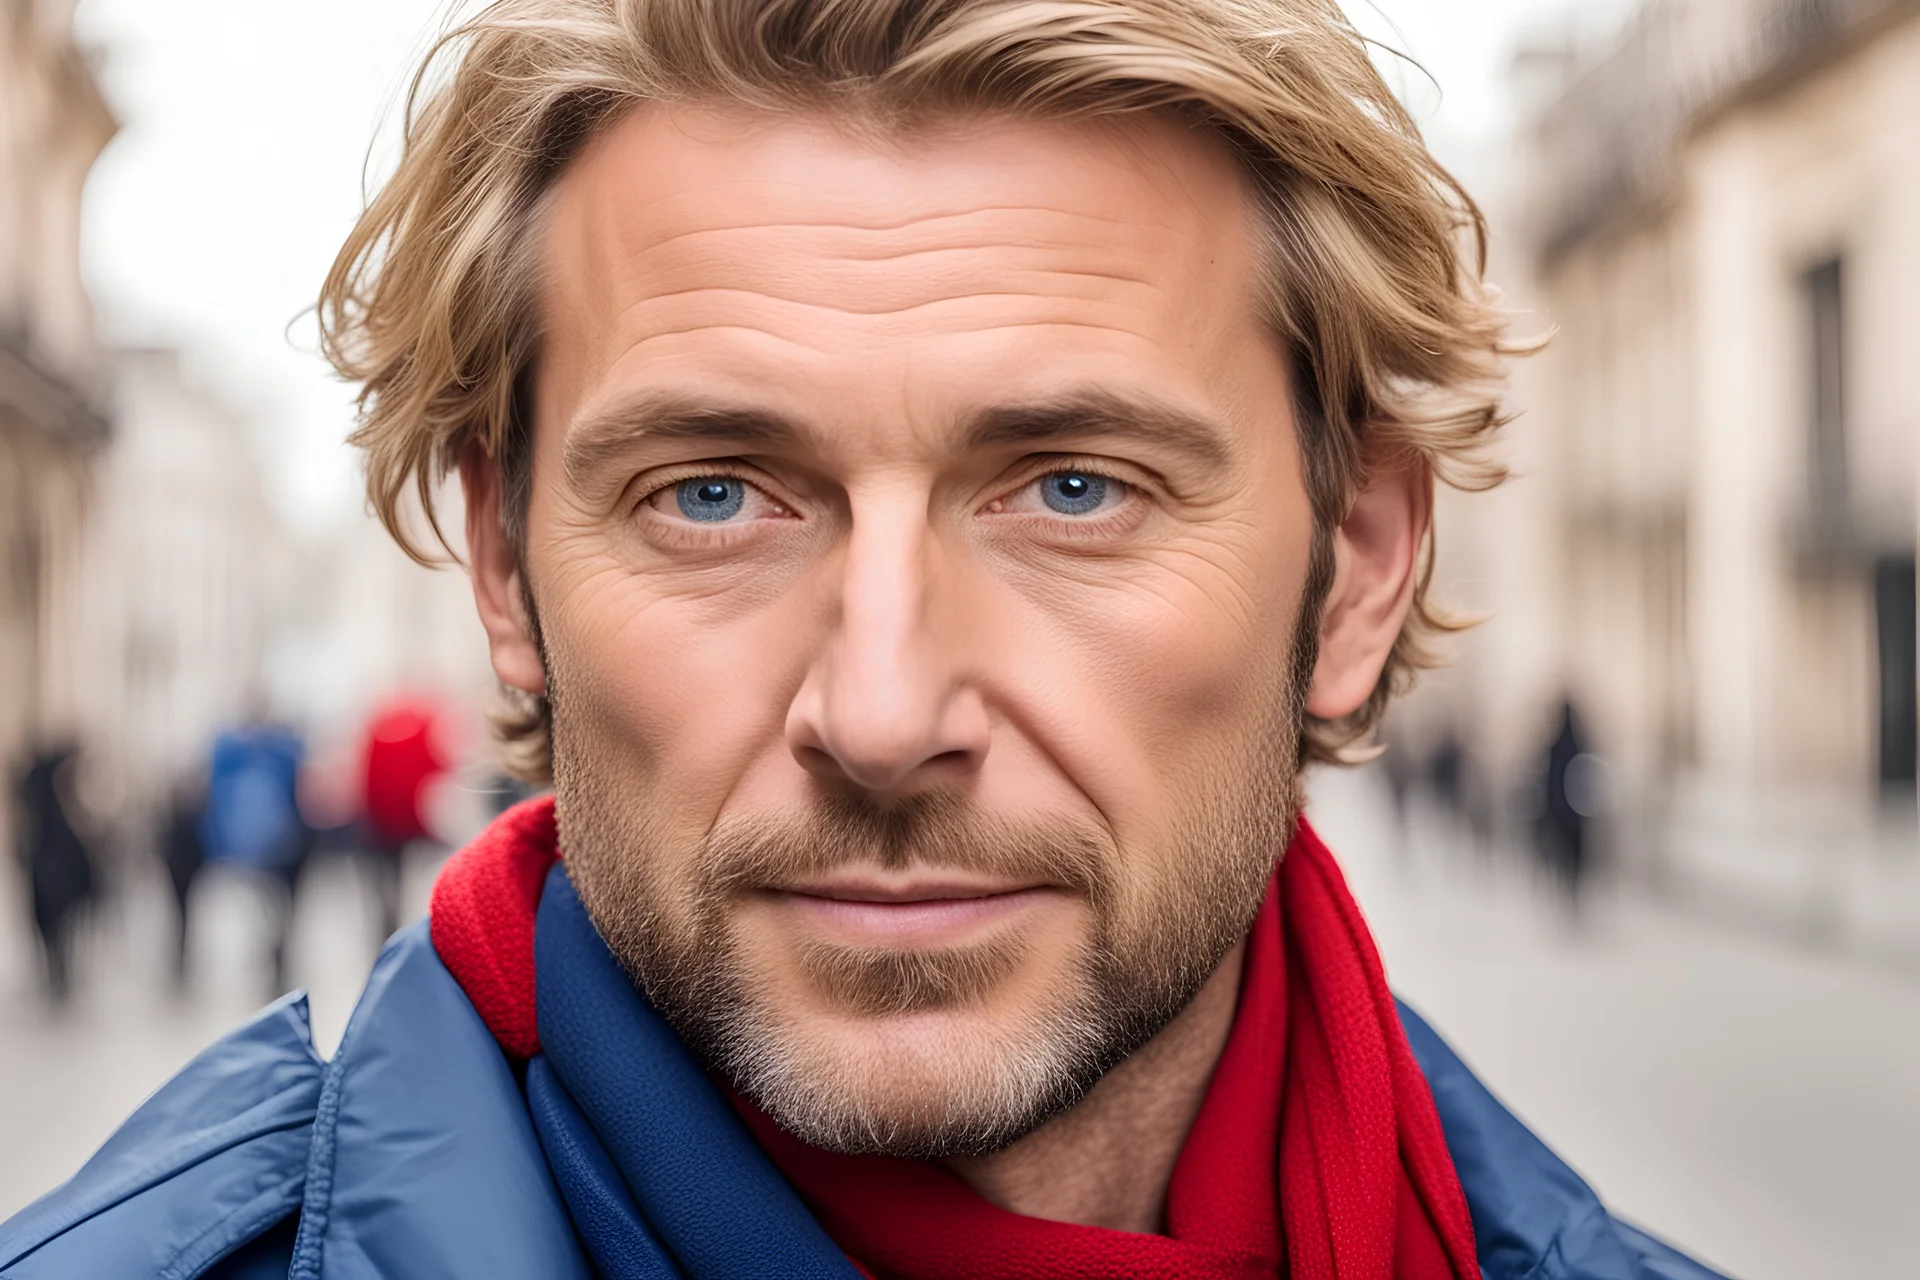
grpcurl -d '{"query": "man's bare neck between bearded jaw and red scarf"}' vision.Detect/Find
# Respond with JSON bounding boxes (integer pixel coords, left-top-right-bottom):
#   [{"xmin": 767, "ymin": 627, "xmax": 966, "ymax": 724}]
[{"xmin": 947, "ymin": 942, "xmax": 1246, "ymax": 1232}]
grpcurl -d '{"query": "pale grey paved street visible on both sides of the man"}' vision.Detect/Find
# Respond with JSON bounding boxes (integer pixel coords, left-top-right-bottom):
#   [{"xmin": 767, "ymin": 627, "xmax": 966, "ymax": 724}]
[{"xmin": 0, "ymin": 773, "xmax": 1920, "ymax": 1280}]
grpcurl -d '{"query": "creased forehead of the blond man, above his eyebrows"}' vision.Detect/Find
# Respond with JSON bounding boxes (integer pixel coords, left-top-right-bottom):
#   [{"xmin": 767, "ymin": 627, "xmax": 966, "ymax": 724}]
[{"xmin": 540, "ymin": 104, "xmax": 1263, "ymax": 445}]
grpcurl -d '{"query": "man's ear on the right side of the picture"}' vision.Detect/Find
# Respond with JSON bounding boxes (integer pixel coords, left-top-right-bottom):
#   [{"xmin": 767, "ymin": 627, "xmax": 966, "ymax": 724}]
[{"xmin": 1308, "ymin": 459, "xmax": 1432, "ymax": 720}]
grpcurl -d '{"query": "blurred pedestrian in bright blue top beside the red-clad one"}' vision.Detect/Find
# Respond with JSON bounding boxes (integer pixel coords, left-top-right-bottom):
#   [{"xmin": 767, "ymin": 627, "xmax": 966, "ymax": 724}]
[{"xmin": 200, "ymin": 720, "xmax": 311, "ymax": 992}]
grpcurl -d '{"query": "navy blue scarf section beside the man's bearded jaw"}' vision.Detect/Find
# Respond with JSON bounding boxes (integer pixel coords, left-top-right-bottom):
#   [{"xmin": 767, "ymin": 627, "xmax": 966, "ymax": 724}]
[{"xmin": 526, "ymin": 864, "xmax": 860, "ymax": 1280}]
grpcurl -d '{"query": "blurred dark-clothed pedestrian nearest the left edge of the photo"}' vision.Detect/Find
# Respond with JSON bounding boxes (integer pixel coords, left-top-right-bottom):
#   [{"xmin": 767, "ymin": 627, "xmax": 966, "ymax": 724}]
[{"xmin": 19, "ymin": 745, "xmax": 96, "ymax": 1004}]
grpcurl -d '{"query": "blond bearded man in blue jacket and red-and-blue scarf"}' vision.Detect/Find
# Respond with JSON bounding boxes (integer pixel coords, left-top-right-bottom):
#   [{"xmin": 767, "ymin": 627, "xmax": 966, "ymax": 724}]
[{"xmin": 0, "ymin": 0, "xmax": 1709, "ymax": 1280}]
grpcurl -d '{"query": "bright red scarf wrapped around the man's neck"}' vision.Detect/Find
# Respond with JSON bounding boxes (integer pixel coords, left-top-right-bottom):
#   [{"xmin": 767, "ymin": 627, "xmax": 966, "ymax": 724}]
[{"xmin": 432, "ymin": 800, "xmax": 1480, "ymax": 1280}]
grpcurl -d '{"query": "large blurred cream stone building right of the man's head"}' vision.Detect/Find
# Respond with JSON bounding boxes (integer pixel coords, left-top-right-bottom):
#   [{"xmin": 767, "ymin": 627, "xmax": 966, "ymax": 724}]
[{"xmin": 1490, "ymin": 0, "xmax": 1920, "ymax": 940}]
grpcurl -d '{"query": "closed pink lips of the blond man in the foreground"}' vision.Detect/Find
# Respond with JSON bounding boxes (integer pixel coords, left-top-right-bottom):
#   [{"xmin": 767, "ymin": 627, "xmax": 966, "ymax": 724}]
[{"xmin": 768, "ymin": 877, "xmax": 1068, "ymax": 948}]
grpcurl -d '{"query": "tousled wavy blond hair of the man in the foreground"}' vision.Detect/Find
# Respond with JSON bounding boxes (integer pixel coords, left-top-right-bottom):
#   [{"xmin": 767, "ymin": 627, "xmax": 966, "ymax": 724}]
[{"xmin": 319, "ymin": 0, "xmax": 1523, "ymax": 777}]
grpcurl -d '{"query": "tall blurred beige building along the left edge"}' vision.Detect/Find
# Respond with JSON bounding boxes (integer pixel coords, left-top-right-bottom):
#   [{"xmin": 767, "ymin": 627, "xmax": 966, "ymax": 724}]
[{"xmin": 0, "ymin": 0, "xmax": 115, "ymax": 837}]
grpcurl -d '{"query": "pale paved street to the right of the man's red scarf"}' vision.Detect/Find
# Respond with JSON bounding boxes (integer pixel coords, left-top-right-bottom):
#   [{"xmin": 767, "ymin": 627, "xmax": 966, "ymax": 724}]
[{"xmin": 1313, "ymin": 773, "xmax": 1920, "ymax": 1280}]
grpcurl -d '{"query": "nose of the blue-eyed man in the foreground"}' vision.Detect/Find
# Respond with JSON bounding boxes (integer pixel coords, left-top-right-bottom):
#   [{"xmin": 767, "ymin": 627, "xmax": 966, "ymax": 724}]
[{"xmin": 787, "ymin": 501, "xmax": 991, "ymax": 794}]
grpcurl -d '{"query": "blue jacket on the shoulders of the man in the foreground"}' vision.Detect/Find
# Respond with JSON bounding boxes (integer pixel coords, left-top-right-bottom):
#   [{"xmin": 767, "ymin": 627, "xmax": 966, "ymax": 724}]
[{"xmin": 0, "ymin": 923, "xmax": 1720, "ymax": 1280}]
